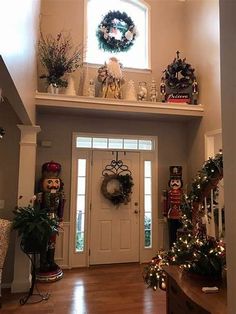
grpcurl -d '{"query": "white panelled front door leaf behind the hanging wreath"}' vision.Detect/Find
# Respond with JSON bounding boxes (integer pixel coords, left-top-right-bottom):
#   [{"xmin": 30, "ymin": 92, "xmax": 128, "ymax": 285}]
[{"xmin": 89, "ymin": 151, "xmax": 140, "ymax": 265}]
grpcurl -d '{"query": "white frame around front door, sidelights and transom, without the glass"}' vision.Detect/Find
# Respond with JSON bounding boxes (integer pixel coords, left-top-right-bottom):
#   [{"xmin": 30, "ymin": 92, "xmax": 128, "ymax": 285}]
[{"xmin": 68, "ymin": 132, "xmax": 159, "ymax": 268}]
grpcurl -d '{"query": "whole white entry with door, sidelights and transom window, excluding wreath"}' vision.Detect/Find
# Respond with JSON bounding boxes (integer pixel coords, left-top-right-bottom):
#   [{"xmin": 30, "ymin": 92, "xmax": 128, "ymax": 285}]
[{"xmin": 68, "ymin": 133, "xmax": 158, "ymax": 268}]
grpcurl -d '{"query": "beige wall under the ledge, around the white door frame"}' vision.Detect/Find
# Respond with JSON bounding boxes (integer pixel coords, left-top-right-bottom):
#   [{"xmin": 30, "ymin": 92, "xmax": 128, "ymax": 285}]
[{"xmin": 36, "ymin": 113, "xmax": 187, "ymax": 221}]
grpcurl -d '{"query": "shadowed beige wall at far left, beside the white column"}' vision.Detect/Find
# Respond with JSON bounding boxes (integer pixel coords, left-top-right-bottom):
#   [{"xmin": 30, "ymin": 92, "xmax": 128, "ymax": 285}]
[{"xmin": 0, "ymin": 102, "xmax": 20, "ymax": 283}]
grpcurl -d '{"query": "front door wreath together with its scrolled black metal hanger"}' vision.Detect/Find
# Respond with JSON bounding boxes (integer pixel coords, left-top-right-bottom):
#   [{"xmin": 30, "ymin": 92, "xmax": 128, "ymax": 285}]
[{"xmin": 101, "ymin": 152, "xmax": 134, "ymax": 205}]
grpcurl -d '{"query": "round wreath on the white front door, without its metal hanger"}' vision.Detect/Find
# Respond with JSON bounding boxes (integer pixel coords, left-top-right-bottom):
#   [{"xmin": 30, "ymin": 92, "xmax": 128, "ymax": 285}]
[{"xmin": 101, "ymin": 174, "xmax": 134, "ymax": 205}]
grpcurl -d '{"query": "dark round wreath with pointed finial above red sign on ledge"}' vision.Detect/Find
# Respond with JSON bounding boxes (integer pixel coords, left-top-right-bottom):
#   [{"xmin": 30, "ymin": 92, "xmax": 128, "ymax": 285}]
[{"xmin": 164, "ymin": 51, "xmax": 196, "ymax": 91}]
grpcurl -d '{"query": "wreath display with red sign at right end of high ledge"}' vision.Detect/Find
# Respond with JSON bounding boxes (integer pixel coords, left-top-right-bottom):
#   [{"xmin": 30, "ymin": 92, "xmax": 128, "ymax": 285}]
[{"xmin": 161, "ymin": 51, "xmax": 199, "ymax": 105}]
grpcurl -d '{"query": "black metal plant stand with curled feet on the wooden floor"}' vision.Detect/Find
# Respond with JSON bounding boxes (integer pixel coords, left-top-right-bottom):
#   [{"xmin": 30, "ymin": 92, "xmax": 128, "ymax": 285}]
[{"xmin": 20, "ymin": 250, "xmax": 50, "ymax": 305}]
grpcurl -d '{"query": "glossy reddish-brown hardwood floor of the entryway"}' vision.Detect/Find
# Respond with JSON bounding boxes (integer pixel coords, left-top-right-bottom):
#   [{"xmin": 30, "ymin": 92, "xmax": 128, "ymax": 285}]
[{"xmin": 0, "ymin": 264, "xmax": 166, "ymax": 314}]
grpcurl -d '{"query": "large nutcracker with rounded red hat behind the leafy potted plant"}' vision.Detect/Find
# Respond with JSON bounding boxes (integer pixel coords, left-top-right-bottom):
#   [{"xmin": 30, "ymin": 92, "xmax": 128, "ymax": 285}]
[{"xmin": 37, "ymin": 161, "xmax": 65, "ymax": 282}]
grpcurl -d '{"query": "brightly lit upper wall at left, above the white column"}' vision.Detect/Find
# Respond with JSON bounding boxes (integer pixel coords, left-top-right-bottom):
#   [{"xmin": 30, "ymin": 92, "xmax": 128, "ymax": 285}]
[{"xmin": 0, "ymin": 0, "xmax": 40, "ymax": 124}]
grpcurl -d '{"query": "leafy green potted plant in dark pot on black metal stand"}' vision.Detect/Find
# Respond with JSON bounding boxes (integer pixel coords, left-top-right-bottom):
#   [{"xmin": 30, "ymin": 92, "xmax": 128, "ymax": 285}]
[{"xmin": 12, "ymin": 202, "xmax": 59, "ymax": 253}]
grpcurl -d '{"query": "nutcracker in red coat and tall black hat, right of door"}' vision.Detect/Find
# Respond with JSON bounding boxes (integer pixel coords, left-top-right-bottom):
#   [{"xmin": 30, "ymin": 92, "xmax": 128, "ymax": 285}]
[{"xmin": 163, "ymin": 166, "xmax": 183, "ymax": 248}]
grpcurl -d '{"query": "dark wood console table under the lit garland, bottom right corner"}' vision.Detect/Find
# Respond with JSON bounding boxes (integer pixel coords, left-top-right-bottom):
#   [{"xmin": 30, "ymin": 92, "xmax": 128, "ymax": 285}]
[{"xmin": 164, "ymin": 265, "xmax": 227, "ymax": 314}]
